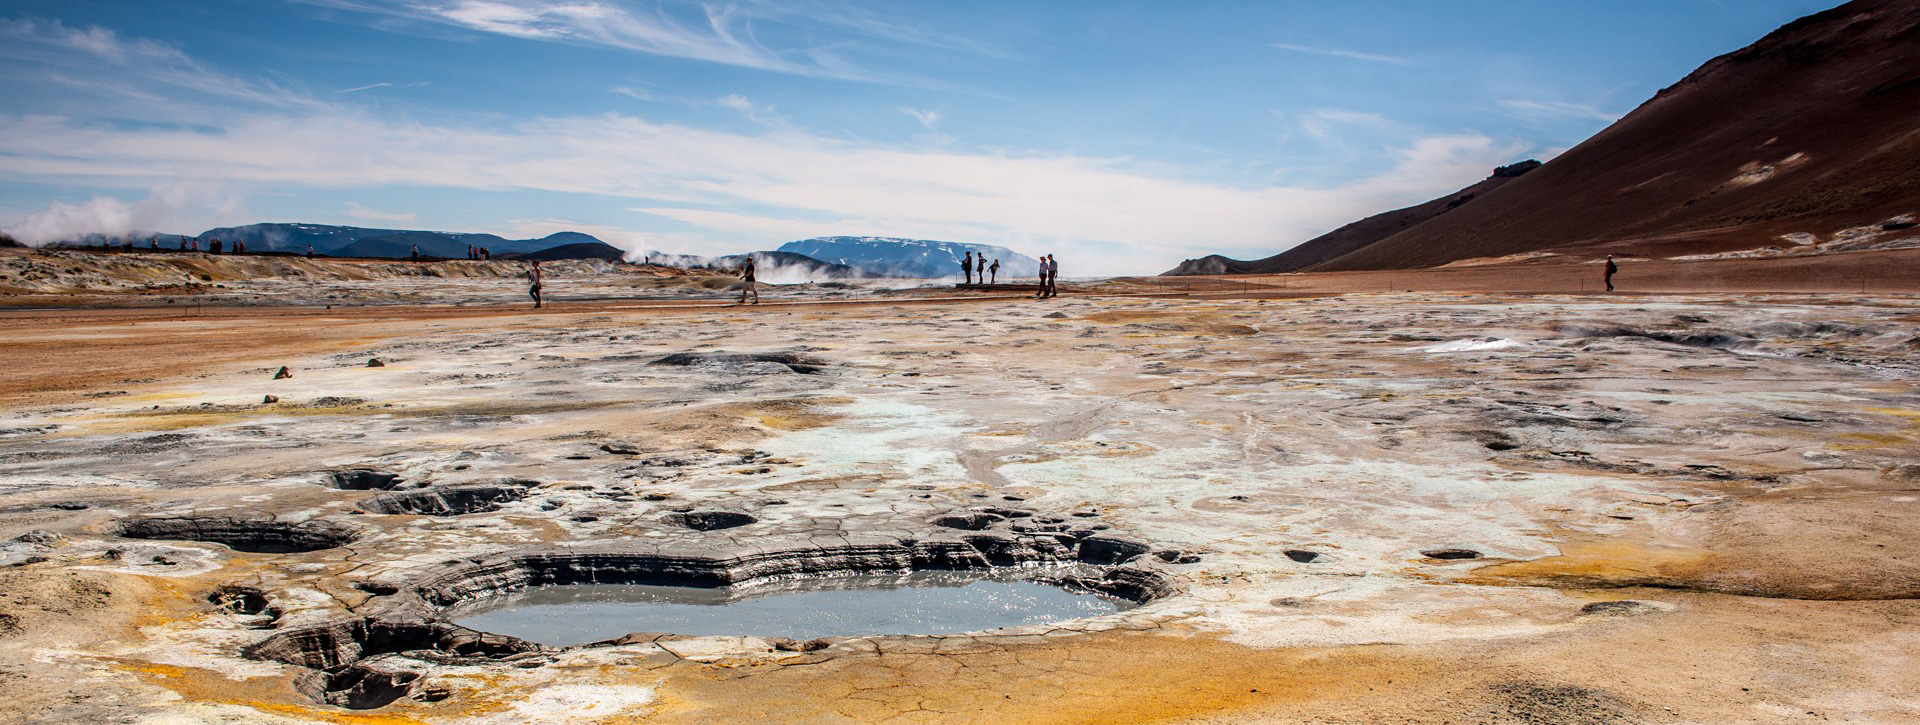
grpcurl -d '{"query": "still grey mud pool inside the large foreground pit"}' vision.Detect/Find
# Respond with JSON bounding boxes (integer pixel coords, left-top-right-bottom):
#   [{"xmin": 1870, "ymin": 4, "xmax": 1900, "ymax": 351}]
[{"xmin": 447, "ymin": 572, "xmax": 1131, "ymax": 646}]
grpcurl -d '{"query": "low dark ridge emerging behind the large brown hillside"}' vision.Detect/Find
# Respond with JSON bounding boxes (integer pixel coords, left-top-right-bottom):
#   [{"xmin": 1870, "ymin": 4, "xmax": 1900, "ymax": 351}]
[{"xmin": 1160, "ymin": 159, "xmax": 1540, "ymax": 276}]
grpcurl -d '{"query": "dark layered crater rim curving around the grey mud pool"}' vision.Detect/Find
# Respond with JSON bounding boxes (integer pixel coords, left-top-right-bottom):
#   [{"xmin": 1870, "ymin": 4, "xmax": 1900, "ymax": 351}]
[{"xmin": 242, "ymin": 533, "xmax": 1183, "ymax": 710}]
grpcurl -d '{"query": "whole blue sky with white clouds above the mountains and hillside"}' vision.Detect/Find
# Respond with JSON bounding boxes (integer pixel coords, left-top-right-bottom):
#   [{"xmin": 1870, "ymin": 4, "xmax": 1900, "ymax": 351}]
[{"xmin": 0, "ymin": 0, "xmax": 1832, "ymax": 276}]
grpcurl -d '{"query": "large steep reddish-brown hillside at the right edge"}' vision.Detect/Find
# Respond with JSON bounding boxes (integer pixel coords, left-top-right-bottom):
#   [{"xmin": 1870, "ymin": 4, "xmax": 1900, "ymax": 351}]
[{"xmin": 1315, "ymin": 0, "xmax": 1920, "ymax": 270}]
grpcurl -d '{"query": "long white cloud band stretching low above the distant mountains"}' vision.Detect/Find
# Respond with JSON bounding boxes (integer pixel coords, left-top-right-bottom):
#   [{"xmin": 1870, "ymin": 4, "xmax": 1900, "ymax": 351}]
[{"xmin": 0, "ymin": 113, "xmax": 1517, "ymax": 274}]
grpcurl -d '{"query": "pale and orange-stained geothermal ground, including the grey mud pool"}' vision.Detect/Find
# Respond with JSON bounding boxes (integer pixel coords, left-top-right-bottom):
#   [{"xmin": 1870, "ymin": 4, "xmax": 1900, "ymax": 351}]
[{"xmin": 0, "ymin": 280, "xmax": 1920, "ymax": 725}]
